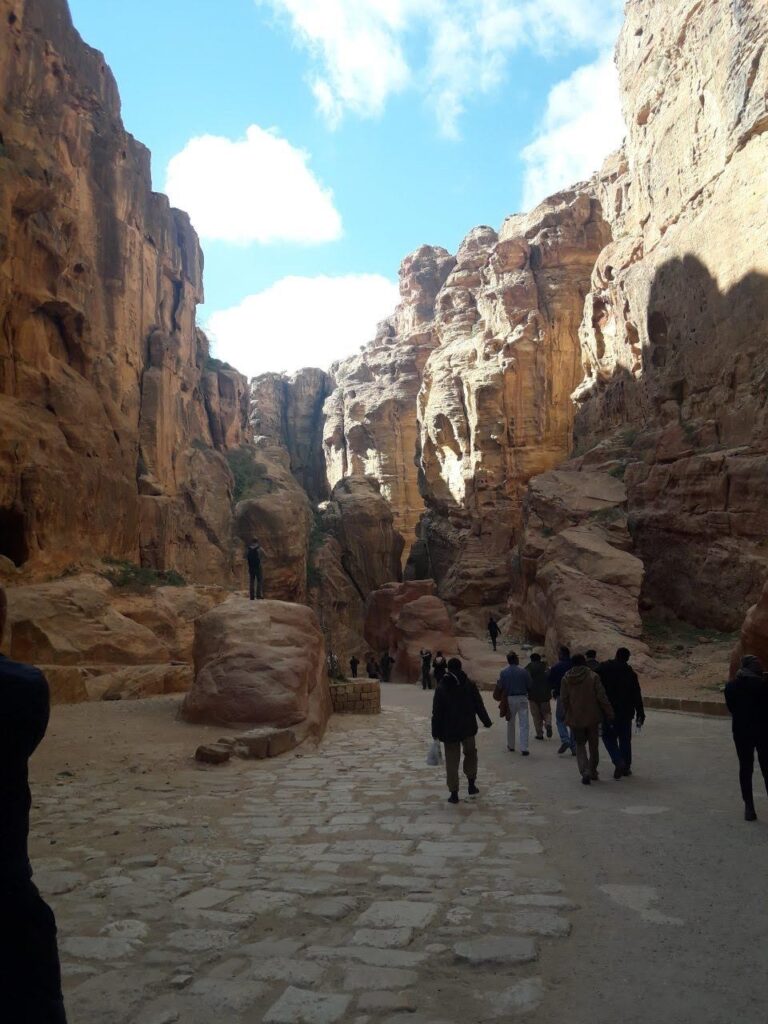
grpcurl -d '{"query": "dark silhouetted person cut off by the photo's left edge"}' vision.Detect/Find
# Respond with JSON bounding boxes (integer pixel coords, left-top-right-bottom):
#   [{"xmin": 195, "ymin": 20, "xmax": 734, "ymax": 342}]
[{"xmin": 0, "ymin": 587, "xmax": 67, "ymax": 1024}]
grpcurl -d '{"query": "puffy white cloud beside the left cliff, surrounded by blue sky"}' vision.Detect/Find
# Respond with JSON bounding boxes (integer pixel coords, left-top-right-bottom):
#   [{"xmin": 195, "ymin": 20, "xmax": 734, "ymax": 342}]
[{"xmin": 165, "ymin": 125, "xmax": 342, "ymax": 245}]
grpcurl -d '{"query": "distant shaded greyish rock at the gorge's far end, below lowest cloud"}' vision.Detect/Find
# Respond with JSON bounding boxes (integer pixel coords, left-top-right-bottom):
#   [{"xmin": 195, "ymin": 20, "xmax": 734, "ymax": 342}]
[{"xmin": 251, "ymin": 369, "xmax": 331, "ymax": 502}]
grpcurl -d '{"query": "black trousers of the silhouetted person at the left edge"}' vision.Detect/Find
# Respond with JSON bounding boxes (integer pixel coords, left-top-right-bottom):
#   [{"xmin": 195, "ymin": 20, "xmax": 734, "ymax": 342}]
[{"xmin": 0, "ymin": 881, "xmax": 67, "ymax": 1024}]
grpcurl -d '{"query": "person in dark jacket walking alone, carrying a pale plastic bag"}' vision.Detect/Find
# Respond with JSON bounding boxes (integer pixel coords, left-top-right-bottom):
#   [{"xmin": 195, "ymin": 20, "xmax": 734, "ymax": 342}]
[{"xmin": 432, "ymin": 657, "xmax": 492, "ymax": 804}]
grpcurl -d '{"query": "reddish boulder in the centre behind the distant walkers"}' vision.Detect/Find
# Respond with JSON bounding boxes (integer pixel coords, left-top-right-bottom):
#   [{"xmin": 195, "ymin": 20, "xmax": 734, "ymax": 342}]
[{"xmin": 365, "ymin": 580, "xmax": 458, "ymax": 683}]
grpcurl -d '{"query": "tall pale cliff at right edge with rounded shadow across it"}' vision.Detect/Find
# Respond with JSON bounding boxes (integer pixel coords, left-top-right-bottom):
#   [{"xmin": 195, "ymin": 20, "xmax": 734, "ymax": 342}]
[{"xmin": 575, "ymin": 0, "xmax": 768, "ymax": 630}]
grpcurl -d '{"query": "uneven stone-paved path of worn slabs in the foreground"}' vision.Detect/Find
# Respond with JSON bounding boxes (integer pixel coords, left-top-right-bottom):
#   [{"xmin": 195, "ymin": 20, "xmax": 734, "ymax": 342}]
[{"xmin": 33, "ymin": 706, "xmax": 573, "ymax": 1024}]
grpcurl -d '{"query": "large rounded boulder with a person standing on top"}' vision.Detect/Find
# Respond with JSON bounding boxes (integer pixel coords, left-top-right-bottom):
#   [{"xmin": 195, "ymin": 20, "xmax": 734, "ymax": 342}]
[{"xmin": 181, "ymin": 595, "xmax": 331, "ymax": 738}]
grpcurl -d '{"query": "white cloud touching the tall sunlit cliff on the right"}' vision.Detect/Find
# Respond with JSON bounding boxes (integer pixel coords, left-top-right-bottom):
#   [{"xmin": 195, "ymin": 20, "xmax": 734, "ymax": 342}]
[{"xmin": 521, "ymin": 53, "xmax": 625, "ymax": 210}]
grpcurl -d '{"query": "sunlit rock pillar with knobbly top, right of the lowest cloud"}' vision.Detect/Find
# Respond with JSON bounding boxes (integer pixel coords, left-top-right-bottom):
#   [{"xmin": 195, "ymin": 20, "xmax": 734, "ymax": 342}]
[{"xmin": 324, "ymin": 246, "xmax": 456, "ymax": 555}]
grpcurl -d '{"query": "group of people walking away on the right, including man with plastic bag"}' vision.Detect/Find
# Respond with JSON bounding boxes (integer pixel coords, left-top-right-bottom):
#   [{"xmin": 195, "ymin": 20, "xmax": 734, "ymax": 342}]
[{"xmin": 432, "ymin": 647, "xmax": 645, "ymax": 804}]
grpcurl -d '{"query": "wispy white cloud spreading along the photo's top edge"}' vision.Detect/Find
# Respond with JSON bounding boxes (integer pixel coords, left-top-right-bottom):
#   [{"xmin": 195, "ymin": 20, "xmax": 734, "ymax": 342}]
[{"xmin": 256, "ymin": 0, "xmax": 624, "ymax": 137}]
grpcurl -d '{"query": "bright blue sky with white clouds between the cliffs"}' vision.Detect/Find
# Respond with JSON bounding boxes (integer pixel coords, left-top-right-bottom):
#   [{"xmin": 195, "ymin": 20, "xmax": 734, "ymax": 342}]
[{"xmin": 70, "ymin": 0, "xmax": 622, "ymax": 374}]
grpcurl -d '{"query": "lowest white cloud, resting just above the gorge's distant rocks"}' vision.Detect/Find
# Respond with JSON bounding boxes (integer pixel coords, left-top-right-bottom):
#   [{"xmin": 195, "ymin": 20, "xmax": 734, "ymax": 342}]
[{"xmin": 205, "ymin": 273, "xmax": 399, "ymax": 377}]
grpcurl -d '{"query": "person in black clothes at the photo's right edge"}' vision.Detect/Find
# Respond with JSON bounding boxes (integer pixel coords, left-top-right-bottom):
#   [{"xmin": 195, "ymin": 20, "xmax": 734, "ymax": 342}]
[{"xmin": 725, "ymin": 654, "xmax": 768, "ymax": 821}]
